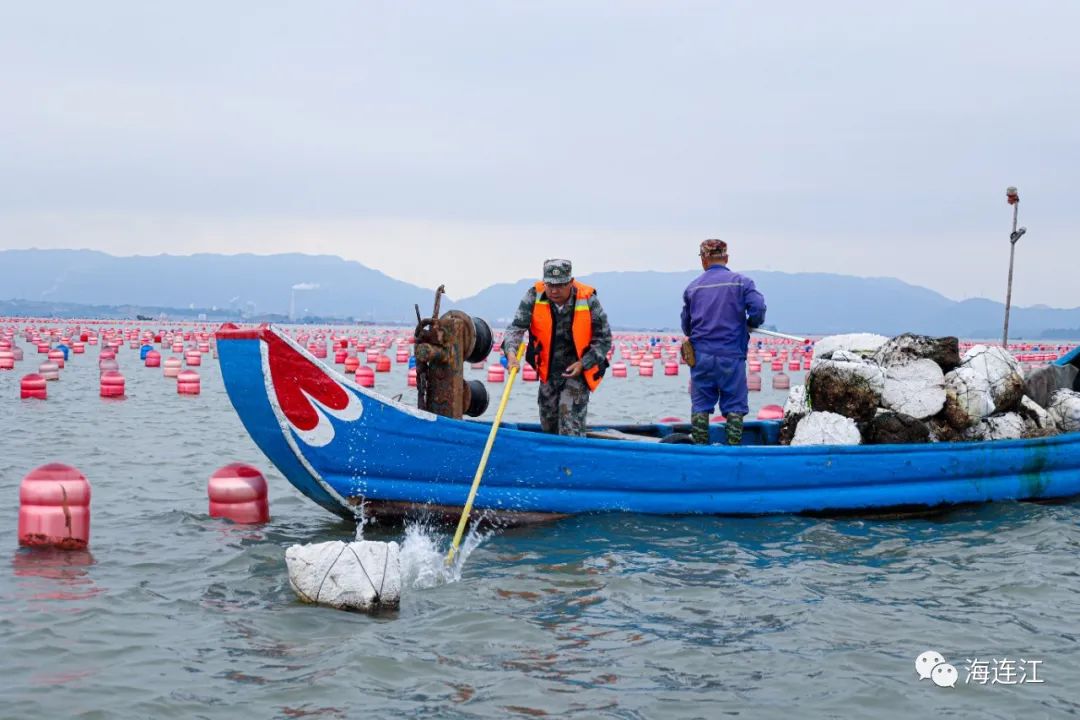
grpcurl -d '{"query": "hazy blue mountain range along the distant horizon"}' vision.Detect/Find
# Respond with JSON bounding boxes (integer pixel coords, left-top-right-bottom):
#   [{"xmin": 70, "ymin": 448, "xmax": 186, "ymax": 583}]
[{"xmin": 0, "ymin": 249, "xmax": 1080, "ymax": 338}]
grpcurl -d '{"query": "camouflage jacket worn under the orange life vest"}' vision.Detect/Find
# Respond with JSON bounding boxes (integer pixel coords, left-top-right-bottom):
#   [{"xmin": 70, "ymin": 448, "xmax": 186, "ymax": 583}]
[{"xmin": 502, "ymin": 287, "xmax": 611, "ymax": 379}]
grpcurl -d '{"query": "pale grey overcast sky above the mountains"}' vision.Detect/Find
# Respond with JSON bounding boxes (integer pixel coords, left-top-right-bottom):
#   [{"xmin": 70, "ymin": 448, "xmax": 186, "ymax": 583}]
[{"xmin": 0, "ymin": 0, "xmax": 1080, "ymax": 307}]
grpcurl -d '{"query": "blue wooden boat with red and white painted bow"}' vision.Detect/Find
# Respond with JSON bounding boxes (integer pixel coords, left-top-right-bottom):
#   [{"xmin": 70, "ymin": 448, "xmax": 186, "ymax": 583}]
[{"xmin": 217, "ymin": 325, "xmax": 1080, "ymax": 521}]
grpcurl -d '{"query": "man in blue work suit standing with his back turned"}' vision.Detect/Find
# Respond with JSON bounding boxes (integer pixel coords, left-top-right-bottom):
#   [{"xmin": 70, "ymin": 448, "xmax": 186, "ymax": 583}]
[{"xmin": 683, "ymin": 240, "xmax": 765, "ymax": 445}]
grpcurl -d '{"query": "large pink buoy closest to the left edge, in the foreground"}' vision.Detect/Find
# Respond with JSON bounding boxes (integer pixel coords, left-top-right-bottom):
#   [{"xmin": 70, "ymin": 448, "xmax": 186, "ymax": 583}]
[{"xmin": 18, "ymin": 463, "xmax": 90, "ymax": 549}]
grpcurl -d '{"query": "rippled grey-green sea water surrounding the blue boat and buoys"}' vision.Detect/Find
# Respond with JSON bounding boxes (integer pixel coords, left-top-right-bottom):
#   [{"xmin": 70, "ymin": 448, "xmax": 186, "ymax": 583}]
[{"xmin": 0, "ymin": 343, "xmax": 1080, "ymax": 718}]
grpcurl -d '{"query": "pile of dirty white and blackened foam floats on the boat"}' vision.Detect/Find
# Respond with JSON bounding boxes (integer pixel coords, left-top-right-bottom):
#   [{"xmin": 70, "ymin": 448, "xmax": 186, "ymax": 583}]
[{"xmin": 781, "ymin": 334, "xmax": 1080, "ymax": 445}]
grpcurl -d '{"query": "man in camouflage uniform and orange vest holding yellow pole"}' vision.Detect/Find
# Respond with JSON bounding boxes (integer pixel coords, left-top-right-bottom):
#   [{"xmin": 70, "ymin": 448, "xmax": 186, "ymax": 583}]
[{"xmin": 502, "ymin": 259, "xmax": 611, "ymax": 437}]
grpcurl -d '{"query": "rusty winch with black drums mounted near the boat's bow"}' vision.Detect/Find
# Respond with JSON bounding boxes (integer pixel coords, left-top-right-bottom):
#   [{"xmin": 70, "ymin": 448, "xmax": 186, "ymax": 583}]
[{"xmin": 414, "ymin": 285, "xmax": 491, "ymax": 419}]
